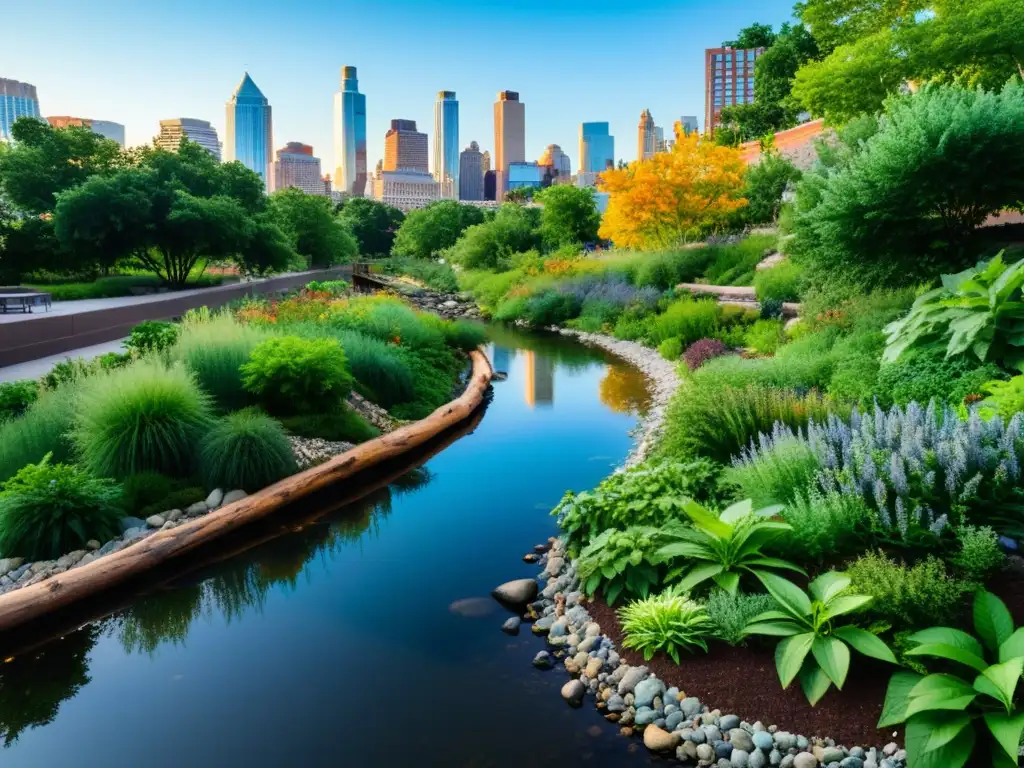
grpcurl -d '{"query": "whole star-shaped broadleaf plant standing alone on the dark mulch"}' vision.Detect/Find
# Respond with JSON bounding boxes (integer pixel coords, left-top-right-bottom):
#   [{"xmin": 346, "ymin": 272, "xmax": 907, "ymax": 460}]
[{"xmin": 744, "ymin": 570, "xmax": 896, "ymax": 707}]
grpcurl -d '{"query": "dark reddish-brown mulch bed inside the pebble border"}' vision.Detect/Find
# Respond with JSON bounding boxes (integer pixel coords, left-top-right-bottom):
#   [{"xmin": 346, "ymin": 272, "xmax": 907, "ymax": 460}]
[{"xmin": 587, "ymin": 600, "xmax": 902, "ymax": 746}]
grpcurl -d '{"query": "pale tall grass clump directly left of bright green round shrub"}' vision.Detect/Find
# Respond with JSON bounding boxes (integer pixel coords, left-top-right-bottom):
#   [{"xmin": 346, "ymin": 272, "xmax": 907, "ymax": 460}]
[{"xmin": 170, "ymin": 313, "xmax": 270, "ymax": 412}]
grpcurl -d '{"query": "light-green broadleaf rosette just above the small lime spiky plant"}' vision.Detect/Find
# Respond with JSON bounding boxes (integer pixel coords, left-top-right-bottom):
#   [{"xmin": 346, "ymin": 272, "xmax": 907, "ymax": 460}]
[{"xmin": 658, "ymin": 499, "xmax": 804, "ymax": 595}]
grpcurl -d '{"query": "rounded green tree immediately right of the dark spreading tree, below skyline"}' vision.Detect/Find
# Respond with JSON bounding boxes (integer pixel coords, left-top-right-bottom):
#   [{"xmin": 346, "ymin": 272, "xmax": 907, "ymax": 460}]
[{"xmin": 270, "ymin": 187, "xmax": 358, "ymax": 267}]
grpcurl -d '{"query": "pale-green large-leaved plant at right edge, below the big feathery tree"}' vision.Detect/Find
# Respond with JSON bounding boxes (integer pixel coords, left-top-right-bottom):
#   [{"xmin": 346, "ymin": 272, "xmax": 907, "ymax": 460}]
[{"xmin": 883, "ymin": 252, "xmax": 1024, "ymax": 370}]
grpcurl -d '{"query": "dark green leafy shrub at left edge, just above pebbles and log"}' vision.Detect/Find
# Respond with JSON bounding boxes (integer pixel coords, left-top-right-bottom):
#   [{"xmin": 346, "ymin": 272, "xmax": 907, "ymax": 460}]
[{"xmin": 0, "ymin": 455, "xmax": 122, "ymax": 560}]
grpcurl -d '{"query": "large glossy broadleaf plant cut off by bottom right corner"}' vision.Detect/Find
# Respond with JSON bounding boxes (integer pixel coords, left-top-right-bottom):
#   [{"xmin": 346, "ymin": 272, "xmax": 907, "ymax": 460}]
[{"xmin": 879, "ymin": 592, "xmax": 1024, "ymax": 768}]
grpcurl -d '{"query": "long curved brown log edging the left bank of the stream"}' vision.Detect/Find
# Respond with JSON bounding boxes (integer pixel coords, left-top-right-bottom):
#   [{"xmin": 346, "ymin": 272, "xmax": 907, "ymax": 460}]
[{"xmin": 0, "ymin": 350, "xmax": 492, "ymax": 633}]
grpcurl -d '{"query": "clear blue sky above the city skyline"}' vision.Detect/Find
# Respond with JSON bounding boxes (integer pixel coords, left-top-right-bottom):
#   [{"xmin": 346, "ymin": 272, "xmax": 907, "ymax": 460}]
[{"xmin": 0, "ymin": 0, "xmax": 793, "ymax": 172}]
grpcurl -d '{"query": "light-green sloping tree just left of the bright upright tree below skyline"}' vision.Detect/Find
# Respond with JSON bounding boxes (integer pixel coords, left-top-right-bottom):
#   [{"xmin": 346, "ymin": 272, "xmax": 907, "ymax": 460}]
[{"xmin": 444, "ymin": 203, "xmax": 541, "ymax": 269}]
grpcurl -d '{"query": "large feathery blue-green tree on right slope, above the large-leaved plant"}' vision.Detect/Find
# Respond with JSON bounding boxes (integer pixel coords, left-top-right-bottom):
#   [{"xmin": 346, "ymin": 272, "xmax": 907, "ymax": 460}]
[{"xmin": 791, "ymin": 82, "xmax": 1024, "ymax": 288}]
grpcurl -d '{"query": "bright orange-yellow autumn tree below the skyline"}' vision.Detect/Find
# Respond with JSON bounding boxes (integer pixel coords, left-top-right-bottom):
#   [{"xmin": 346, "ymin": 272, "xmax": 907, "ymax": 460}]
[{"xmin": 599, "ymin": 123, "xmax": 746, "ymax": 249}]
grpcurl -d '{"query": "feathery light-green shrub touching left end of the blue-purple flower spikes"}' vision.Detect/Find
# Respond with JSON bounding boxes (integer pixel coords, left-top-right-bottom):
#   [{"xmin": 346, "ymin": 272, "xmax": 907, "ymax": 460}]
[{"xmin": 725, "ymin": 438, "xmax": 819, "ymax": 507}]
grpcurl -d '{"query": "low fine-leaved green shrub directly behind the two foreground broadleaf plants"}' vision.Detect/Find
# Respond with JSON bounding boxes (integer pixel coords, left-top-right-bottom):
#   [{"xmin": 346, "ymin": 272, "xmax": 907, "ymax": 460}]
[{"xmin": 847, "ymin": 552, "xmax": 972, "ymax": 629}]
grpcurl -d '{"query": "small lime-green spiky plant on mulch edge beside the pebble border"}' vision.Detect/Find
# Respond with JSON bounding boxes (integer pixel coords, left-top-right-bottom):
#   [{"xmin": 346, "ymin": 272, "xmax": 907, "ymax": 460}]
[{"xmin": 618, "ymin": 590, "xmax": 711, "ymax": 664}]
